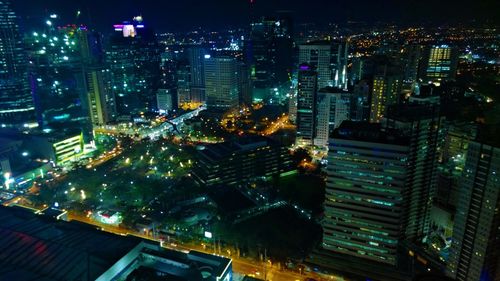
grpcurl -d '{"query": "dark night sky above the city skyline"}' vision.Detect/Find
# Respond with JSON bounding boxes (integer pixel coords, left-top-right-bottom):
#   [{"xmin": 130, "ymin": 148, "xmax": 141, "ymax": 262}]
[{"xmin": 11, "ymin": 0, "xmax": 500, "ymax": 31}]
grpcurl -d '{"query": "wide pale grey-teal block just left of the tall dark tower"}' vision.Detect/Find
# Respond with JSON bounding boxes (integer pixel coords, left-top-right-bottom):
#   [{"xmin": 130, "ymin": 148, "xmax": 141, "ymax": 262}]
[{"xmin": 205, "ymin": 57, "xmax": 239, "ymax": 110}]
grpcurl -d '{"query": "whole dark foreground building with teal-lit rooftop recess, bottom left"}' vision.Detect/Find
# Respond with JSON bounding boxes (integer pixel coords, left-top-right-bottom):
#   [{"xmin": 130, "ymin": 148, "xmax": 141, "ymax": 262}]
[{"xmin": 0, "ymin": 207, "xmax": 232, "ymax": 281}]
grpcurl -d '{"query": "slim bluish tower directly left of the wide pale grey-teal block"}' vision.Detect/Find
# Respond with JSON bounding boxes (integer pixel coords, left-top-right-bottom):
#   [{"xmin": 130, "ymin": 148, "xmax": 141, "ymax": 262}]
[{"xmin": 187, "ymin": 46, "xmax": 208, "ymax": 103}]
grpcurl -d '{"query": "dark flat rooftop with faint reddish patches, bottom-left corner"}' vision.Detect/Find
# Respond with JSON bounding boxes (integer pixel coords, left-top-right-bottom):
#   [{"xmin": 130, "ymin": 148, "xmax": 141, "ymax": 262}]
[{"xmin": 0, "ymin": 207, "xmax": 140, "ymax": 281}]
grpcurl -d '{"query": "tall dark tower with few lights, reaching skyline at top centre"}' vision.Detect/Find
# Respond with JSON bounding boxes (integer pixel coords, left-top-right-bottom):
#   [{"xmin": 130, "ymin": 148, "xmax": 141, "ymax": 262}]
[{"xmin": 246, "ymin": 12, "xmax": 293, "ymax": 89}]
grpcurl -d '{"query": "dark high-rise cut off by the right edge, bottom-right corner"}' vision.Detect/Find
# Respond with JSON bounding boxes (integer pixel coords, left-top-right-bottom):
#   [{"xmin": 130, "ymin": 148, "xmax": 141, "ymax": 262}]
[{"xmin": 448, "ymin": 130, "xmax": 500, "ymax": 281}]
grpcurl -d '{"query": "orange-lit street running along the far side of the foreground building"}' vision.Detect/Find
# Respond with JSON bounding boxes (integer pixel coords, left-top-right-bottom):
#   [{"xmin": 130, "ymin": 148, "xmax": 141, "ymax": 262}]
[{"xmin": 68, "ymin": 212, "xmax": 344, "ymax": 281}]
